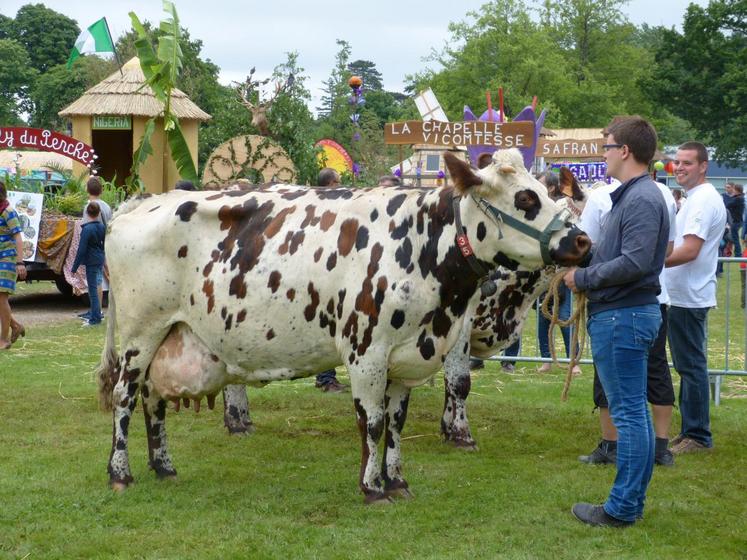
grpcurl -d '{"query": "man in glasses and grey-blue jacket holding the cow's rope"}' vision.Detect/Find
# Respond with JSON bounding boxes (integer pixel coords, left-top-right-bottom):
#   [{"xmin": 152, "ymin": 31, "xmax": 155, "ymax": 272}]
[{"xmin": 564, "ymin": 117, "xmax": 669, "ymax": 527}]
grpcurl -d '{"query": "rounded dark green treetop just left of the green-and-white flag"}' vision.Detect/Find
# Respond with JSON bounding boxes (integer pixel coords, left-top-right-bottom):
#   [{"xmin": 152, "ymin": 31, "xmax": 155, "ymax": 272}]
[{"xmin": 13, "ymin": 4, "xmax": 79, "ymax": 72}]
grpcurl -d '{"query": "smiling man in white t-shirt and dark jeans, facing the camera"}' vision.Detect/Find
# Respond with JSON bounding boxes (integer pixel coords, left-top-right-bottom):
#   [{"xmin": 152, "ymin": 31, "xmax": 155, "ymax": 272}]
[{"xmin": 665, "ymin": 142, "xmax": 726, "ymax": 455}]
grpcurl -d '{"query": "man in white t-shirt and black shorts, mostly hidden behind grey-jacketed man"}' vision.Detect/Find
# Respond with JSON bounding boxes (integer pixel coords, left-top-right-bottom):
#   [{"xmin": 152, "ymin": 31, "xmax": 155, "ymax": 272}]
[{"xmin": 578, "ymin": 180, "xmax": 677, "ymax": 466}]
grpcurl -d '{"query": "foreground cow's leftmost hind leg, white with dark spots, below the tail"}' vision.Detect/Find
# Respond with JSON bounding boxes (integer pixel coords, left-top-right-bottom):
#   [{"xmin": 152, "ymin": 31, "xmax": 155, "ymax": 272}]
[{"xmin": 107, "ymin": 349, "xmax": 142, "ymax": 491}]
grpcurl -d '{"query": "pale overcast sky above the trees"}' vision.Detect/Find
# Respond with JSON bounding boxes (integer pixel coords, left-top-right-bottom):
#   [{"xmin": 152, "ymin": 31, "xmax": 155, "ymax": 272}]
[{"xmin": 0, "ymin": 0, "xmax": 707, "ymax": 111}]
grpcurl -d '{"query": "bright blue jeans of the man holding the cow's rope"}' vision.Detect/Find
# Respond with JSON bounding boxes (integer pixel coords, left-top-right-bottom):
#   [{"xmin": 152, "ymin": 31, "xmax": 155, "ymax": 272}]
[{"xmin": 587, "ymin": 304, "xmax": 661, "ymax": 521}]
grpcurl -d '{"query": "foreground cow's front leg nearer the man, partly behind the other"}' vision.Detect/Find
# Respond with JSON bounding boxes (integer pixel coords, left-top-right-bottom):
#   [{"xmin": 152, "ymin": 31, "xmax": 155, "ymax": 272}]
[{"xmin": 382, "ymin": 381, "xmax": 412, "ymax": 498}]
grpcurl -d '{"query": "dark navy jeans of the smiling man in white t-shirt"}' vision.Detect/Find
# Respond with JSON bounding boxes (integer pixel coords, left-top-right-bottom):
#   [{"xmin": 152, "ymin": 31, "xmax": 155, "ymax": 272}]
[{"xmin": 669, "ymin": 305, "xmax": 713, "ymax": 447}]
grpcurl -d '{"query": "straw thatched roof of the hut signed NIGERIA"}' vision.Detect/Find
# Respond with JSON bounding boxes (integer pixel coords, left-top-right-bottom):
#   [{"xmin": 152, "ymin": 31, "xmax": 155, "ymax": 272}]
[{"xmin": 59, "ymin": 57, "xmax": 210, "ymax": 121}]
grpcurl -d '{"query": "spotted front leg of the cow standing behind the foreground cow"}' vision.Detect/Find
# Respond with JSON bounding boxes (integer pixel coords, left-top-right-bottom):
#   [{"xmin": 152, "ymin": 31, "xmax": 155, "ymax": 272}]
[{"xmin": 441, "ymin": 321, "xmax": 477, "ymax": 450}]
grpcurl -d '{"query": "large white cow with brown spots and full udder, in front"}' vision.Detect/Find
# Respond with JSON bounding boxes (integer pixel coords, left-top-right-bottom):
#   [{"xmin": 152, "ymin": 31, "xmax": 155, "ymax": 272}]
[{"xmin": 99, "ymin": 150, "xmax": 590, "ymax": 503}]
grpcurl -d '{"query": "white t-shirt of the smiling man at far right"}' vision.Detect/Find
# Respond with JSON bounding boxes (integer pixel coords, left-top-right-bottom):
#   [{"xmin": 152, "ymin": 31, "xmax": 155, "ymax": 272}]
[{"xmin": 666, "ymin": 183, "xmax": 726, "ymax": 309}]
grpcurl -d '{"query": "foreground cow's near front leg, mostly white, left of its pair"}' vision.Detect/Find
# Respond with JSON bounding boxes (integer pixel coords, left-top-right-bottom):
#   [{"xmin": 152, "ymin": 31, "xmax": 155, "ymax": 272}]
[{"xmin": 348, "ymin": 367, "xmax": 390, "ymax": 504}]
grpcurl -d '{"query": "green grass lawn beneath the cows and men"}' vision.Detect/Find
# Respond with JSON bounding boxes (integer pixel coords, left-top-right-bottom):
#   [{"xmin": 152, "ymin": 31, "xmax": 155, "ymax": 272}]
[{"xmin": 0, "ymin": 282, "xmax": 747, "ymax": 560}]
